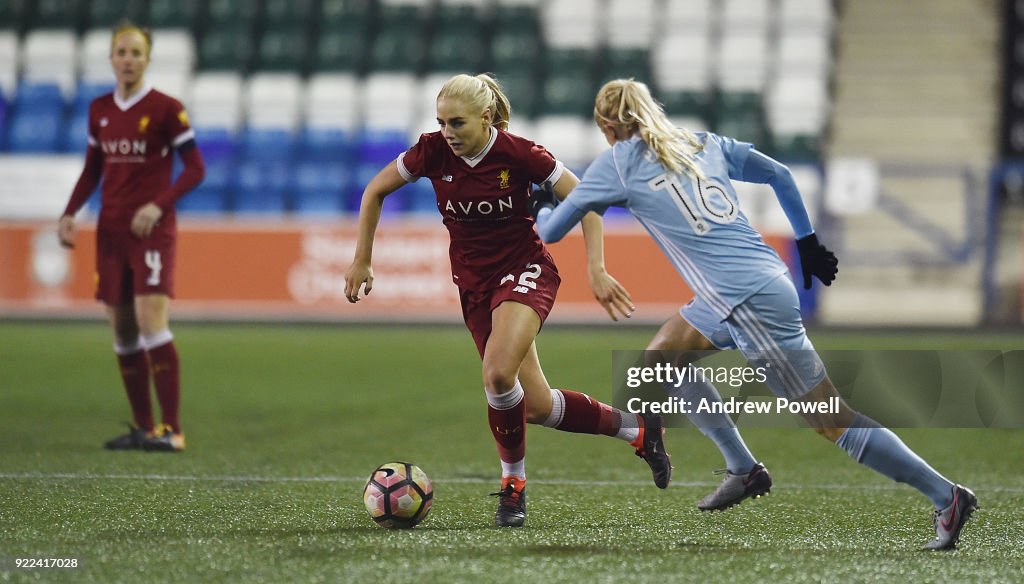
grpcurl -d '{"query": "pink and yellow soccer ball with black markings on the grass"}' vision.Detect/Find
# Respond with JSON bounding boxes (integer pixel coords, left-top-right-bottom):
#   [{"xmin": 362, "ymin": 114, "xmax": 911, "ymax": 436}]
[{"xmin": 362, "ymin": 462, "xmax": 434, "ymax": 529}]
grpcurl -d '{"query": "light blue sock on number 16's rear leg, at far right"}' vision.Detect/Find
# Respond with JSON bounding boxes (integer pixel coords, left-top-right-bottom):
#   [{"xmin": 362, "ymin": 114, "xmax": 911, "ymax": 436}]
[{"xmin": 836, "ymin": 414, "xmax": 954, "ymax": 509}]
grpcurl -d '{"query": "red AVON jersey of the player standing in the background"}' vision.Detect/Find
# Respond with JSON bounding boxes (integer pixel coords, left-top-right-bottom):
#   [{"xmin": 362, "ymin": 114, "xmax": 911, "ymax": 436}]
[{"xmin": 84, "ymin": 86, "xmax": 195, "ymax": 233}]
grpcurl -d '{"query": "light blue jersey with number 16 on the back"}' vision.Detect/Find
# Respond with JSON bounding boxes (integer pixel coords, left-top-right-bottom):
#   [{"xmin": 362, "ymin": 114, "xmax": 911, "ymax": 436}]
[{"xmin": 539, "ymin": 132, "xmax": 790, "ymax": 320}]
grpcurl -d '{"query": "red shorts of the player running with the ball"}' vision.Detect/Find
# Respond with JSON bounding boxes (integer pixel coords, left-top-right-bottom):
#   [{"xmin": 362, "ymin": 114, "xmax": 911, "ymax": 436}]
[{"xmin": 459, "ymin": 253, "xmax": 562, "ymax": 358}]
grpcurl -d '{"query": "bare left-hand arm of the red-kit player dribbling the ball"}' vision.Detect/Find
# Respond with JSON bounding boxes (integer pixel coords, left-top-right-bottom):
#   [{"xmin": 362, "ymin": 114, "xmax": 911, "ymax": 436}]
[{"xmin": 345, "ymin": 162, "xmax": 406, "ymax": 302}]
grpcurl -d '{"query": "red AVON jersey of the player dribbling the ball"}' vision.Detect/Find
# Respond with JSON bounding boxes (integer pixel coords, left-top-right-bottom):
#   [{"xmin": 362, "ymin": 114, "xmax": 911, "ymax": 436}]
[{"xmin": 397, "ymin": 129, "xmax": 565, "ymax": 290}]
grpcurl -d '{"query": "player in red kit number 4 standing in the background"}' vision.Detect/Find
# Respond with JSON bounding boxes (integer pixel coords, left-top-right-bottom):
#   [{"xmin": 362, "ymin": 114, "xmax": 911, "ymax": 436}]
[{"xmin": 58, "ymin": 23, "xmax": 205, "ymax": 452}]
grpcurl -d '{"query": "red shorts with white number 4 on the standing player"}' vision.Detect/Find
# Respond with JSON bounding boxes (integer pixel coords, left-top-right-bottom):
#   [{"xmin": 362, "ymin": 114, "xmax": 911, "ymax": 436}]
[{"xmin": 96, "ymin": 226, "xmax": 177, "ymax": 306}]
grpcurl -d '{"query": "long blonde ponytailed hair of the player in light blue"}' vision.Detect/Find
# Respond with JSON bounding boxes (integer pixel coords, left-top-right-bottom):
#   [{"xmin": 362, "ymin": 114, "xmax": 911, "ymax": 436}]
[{"xmin": 594, "ymin": 79, "xmax": 703, "ymax": 178}]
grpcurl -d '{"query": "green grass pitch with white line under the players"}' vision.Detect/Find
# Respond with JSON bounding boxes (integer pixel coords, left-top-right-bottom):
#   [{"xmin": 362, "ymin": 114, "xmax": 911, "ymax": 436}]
[{"xmin": 0, "ymin": 322, "xmax": 1024, "ymax": 582}]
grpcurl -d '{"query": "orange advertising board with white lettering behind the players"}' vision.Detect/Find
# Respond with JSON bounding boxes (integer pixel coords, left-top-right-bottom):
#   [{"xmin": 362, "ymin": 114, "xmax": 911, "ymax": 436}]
[{"xmin": 0, "ymin": 219, "xmax": 784, "ymax": 322}]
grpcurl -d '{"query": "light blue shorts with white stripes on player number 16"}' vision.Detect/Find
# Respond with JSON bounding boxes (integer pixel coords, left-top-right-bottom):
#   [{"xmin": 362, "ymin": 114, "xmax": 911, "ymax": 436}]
[{"xmin": 679, "ymin": 275, "xmax": 825, "ymax": 400}]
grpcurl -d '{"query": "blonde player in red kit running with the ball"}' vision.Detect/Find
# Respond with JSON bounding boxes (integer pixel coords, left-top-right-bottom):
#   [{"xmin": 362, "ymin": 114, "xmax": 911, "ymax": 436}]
[{"xmin": 345, "ymin": 75, "xmax": 672, "ymax": 527}]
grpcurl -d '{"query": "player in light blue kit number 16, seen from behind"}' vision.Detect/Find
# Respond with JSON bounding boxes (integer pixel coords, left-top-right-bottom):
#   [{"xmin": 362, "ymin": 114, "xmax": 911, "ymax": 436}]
[{"xmin": 532, "ymin": 80, "xmax": 978, "ymax": 550}]
